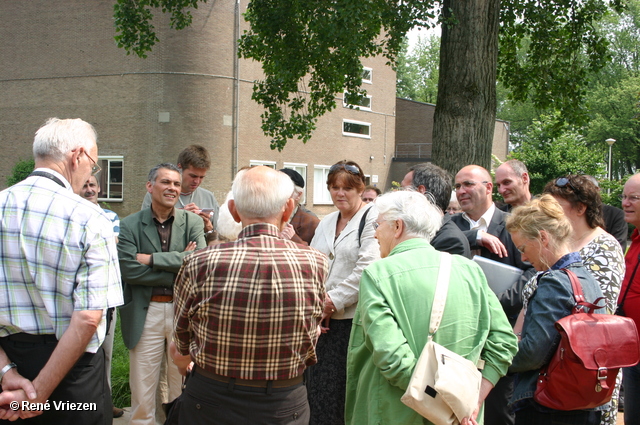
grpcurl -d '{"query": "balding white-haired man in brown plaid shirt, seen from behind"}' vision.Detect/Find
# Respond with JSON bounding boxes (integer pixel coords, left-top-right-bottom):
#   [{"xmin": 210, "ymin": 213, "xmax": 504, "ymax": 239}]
[{"xmin": 173, "ymin": 166, "xmax": 328, "ymax": 425}]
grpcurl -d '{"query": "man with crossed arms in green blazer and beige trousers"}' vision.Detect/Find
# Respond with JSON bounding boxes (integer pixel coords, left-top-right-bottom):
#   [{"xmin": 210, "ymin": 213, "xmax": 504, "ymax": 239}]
[{"xmin": 118, "ymin": 163, "xmax": 205, "ymax": 425}]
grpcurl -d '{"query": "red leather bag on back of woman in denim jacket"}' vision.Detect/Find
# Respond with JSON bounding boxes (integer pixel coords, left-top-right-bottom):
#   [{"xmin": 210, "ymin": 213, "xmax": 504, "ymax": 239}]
[{"xmin": 533, "ymin": 269, "xmax": 640, "ymax": 410}]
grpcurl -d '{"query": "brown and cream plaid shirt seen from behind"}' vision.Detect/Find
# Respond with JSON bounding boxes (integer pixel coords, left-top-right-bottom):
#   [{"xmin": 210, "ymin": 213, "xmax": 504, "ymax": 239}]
[{"xmin": 174, "ymin": 223, "xmax": 328, "ymax": 380}]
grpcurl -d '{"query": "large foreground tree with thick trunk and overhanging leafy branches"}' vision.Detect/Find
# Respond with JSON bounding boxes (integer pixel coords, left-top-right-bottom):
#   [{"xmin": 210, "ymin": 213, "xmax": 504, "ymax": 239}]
[{"xmin": 115, "ymin": 0, "xmax": 621, "ymax": 169}]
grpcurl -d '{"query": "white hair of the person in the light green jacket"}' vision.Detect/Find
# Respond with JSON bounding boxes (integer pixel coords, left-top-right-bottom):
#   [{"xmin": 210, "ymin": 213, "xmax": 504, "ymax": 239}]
[{"xmin": 374, "ymin": 190, "xmax": 443, "ymax": 242}]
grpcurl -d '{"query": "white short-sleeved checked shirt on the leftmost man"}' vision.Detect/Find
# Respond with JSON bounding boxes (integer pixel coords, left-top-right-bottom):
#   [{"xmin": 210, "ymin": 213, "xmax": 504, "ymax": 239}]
[{"xmin": 0, "ymin": 169, "xmax": 123, "ymax": 353}]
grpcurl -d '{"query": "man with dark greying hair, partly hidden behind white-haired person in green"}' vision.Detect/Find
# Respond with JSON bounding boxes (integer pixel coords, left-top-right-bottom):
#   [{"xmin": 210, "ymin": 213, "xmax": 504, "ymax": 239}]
[{"xmin": 401, "ymin": 162, "xmax": 471, "ymax": 258}]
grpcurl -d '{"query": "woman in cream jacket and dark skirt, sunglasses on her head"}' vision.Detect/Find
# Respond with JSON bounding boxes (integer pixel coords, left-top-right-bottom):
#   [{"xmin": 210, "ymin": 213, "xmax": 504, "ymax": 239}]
[{"xmin": 305, "ymin": 161, "xmax": 380, "ymax": 425}]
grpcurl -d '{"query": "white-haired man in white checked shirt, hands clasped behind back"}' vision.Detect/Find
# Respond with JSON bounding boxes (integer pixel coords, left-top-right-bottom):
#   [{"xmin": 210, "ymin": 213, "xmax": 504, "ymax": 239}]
[{"xmin": 0, "ymin": 118, "xmax": 122, "ymax": 424}]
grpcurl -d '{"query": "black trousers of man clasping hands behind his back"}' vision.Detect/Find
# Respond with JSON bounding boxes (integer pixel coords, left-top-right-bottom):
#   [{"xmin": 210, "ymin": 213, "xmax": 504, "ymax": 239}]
[{"xmin": 0, "ymin": 334, "xmax": 113, "ymax": 425}]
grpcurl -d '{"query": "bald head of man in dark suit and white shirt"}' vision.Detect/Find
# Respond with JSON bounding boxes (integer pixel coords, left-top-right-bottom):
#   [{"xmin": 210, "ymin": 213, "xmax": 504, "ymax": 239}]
[{"xmin": 455, "ymin": 165, "xmax": 493, "ymax": 220}]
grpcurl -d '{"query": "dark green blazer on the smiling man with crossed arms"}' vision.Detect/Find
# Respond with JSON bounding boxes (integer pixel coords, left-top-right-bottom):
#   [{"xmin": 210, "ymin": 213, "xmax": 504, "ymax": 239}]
[{"xmin": 118, "ymin": 208, "xmax": 206, "ymax": 350}]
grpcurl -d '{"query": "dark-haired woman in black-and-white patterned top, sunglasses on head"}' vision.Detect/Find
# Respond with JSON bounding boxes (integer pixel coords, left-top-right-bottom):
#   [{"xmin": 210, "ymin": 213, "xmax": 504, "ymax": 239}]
[{"xmin": 540, "ymin": 175, "xmax": 625, "ymax": 425}]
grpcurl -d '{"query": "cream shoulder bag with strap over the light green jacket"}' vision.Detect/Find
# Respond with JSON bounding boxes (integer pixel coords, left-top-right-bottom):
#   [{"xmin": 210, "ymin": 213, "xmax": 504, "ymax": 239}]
[{"xmin": 401, "ymin": 252, "xmax": 482, "ymax": 425}]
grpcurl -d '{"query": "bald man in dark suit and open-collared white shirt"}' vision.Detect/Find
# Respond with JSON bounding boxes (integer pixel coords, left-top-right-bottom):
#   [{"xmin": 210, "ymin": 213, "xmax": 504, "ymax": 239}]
[{"xmin": 451, "ymin": 165, "xmax": 535, "ymax": 425}]
